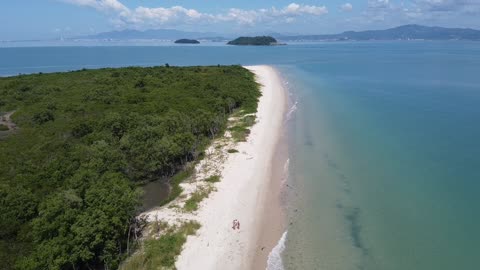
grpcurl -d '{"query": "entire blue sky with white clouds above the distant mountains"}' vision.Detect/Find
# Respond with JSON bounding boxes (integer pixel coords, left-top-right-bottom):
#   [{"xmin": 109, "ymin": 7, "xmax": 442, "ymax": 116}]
[{"xmin": 0, "ymin": 0, "xmax": 480, "ymax": 40}]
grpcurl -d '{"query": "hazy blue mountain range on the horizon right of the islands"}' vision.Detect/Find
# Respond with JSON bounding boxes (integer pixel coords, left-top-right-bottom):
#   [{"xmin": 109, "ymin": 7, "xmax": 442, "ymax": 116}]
[{"xmin": 276, "ymin": 24, "xmax": 480, "ymax": 41}]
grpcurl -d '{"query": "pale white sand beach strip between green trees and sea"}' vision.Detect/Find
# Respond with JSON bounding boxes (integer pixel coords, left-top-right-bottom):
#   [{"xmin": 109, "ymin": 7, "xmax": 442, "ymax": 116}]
[{"xmin": 141, "ymin": 66, "xmax": 287, "ymax": 269}]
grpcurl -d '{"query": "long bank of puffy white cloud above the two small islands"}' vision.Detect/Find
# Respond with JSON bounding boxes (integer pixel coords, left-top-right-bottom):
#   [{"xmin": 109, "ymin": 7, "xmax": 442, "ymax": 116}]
[{"xmin": 63, "ymin": 0, "xmax": 328, "ymax": 28}]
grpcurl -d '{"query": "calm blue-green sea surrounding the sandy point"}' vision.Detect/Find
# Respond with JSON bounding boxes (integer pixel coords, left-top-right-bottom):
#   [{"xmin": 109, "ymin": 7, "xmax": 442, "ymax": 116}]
[{"xmin": 0, "ymin": 41, "xmax": 480, "ymax": 270}]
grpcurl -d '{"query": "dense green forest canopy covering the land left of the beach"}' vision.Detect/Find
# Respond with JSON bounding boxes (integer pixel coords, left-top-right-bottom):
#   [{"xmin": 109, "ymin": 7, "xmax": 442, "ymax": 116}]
[{"xmin": 0, "ymin": 66, "xmax": 260, "ymax": 269}]
